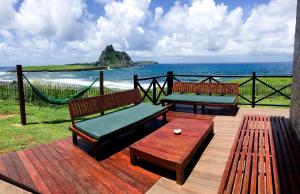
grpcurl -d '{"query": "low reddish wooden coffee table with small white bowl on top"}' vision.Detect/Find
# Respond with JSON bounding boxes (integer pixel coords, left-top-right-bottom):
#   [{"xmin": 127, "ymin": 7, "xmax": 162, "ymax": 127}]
[{"xmin": 130, "ymin": 118, "xmax": 213, "ymax": 185}]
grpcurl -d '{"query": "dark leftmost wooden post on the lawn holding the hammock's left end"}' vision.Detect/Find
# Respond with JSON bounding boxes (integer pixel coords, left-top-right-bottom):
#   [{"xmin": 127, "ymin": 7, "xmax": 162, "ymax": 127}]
[{"xmin": 16, "ymin": 65, "xmax": 26, "ymax": 125}]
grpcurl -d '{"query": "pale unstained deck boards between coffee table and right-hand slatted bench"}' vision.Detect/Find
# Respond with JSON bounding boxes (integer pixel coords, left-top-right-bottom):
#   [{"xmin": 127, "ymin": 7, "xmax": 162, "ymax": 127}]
[{"xmin": 147, "ymin": 108, "xmax": 289, "ymax": 194}]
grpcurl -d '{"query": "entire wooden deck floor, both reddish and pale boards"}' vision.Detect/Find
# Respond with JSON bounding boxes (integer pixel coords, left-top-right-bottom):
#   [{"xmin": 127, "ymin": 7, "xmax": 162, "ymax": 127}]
[{"xmin": 0, "ymin": 108, "xmax": 289, "ymax": 193}]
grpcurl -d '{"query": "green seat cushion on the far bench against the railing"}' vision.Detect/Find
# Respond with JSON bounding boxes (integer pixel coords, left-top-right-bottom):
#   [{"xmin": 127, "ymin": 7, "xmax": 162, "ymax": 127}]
[{"xmin": 163, "ymin": 94, "xmax": 237, "ymax": 104}]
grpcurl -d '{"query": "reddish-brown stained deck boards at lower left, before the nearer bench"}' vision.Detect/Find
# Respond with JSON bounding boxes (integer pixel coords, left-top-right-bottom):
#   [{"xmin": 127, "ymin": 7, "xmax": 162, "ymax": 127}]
[{"xmin": 0, "ymin": 139, "xmax": 159, "ymax": 193}]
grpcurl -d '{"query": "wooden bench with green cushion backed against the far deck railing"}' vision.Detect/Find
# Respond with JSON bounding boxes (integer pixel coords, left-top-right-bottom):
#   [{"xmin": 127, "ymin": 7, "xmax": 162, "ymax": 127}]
[{"xmin": 161, "ymin": 82, "xmax": 239, "ymax": 115}]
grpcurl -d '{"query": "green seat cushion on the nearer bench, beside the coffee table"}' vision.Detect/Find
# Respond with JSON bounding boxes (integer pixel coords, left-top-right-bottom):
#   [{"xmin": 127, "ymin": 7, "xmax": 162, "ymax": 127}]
[{"xmin": 75, "ymin": 103, "xmax": 165, "ymax": 139}]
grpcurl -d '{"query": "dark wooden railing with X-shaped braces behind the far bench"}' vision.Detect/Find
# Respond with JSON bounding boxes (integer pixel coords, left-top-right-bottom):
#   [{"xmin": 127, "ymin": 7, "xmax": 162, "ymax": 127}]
[{"xmin": 133, "ymin": 71, "xmax": 292, "ymax": 108}]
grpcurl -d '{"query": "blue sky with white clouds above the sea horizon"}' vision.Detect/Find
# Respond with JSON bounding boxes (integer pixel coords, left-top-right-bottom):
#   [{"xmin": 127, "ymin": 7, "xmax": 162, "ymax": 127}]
[{"xmin": 0, "ymin": 0, "xmax": 297, "ymax": 67}]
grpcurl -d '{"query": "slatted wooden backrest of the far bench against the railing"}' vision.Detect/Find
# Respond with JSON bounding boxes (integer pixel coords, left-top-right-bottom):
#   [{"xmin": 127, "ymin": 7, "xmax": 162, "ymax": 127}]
[{"xmin": 172, "ymin": 82, "xmax": 239, "ymax": 95}]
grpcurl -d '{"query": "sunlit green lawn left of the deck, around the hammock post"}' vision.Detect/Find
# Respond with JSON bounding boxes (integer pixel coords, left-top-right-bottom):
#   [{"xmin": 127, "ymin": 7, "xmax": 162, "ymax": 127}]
[{"xmin": 0, "ymin": 101, "xmax": 71, "ymax": 154}]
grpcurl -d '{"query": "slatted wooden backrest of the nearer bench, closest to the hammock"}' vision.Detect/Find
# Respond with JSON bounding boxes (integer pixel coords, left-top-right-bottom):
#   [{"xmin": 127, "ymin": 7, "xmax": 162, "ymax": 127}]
[{"xmin": 68, "ymin": 89, "xmax": 143, "ymax": 121}]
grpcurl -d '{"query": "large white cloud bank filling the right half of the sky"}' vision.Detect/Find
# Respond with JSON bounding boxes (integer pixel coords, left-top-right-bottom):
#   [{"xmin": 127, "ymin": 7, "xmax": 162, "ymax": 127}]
[{"xmin": 156, "ymin": 0, "xmax": 296, "ymax": 56}]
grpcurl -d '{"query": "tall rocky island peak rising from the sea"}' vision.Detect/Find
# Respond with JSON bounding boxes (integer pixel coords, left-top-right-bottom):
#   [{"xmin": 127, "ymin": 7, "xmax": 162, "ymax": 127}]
[{"xmin": 98, "ymin": 45, "xmax": 134, "ymax": 68}]
